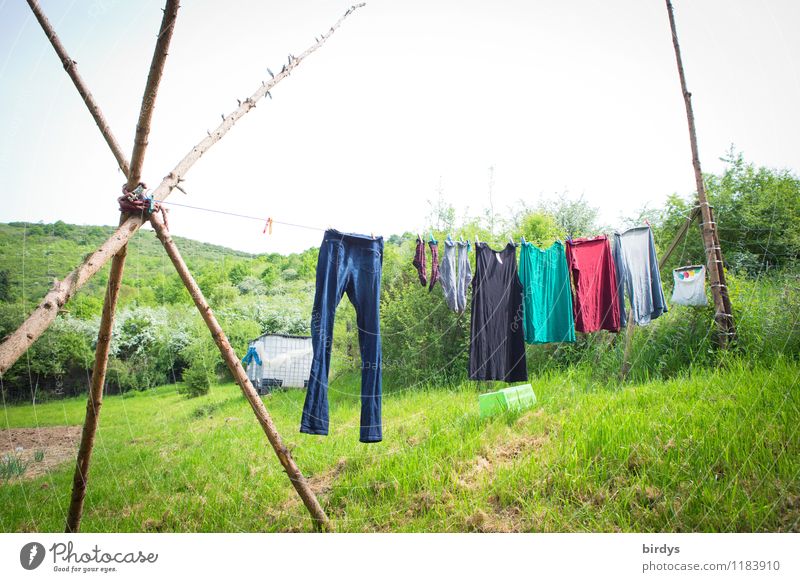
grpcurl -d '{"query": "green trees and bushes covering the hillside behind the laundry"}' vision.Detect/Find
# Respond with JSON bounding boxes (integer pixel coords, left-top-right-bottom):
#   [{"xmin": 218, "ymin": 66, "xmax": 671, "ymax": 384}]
[{"xmin": 0, "ymin": 151, "xmax": 800, "ymax": 401}]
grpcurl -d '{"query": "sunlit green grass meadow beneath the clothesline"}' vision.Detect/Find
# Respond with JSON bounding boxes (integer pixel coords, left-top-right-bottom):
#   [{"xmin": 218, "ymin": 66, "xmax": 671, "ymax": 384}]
[{"xmin": 0, "ymin": 359, "xmax": 800, "ymax": 532}]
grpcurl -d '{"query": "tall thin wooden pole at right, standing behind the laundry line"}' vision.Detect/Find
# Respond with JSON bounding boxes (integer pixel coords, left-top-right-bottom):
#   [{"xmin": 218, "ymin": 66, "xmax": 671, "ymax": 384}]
[{"xmin": 666, "ymin": 0, "xmax": 735, "ymax": 348}]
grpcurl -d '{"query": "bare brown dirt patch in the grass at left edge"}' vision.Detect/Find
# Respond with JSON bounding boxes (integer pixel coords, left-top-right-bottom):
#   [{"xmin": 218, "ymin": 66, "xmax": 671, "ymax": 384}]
[{"xmin": 0, "ymin": 426, "xmax": 81, "ymax": 483}]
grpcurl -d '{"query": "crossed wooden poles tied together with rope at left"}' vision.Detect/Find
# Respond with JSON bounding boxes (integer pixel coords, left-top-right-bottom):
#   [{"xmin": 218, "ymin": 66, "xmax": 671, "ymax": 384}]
[{"xmin": 0, "ymin": 0, "xmax": 364, "ymax": 533}]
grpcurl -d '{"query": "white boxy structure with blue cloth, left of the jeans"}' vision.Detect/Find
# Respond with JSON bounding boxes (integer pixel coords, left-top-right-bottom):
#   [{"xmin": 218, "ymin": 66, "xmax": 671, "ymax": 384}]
[{"xmin": 242, "ymin": 333, "xmax": 313, "ymax": 394}]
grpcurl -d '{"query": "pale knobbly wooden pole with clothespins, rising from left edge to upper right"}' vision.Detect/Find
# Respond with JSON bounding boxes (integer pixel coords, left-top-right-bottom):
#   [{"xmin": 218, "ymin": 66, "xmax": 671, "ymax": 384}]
[{"xmin": 0, "ymin": 4, "xmax": 364, "ymax": 375}]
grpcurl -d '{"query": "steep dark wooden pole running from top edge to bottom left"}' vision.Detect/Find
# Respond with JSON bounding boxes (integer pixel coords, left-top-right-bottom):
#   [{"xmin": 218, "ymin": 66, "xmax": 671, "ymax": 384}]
[{"xmin": 65, "ymin": 0, "xmax": 180, "ymax": 533}]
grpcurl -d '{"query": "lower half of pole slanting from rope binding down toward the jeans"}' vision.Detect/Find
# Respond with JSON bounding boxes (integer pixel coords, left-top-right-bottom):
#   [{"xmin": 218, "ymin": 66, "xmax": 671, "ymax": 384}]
[{"xmin": 150, "ymin": 214, "xmax": 330, "ymax": 530}]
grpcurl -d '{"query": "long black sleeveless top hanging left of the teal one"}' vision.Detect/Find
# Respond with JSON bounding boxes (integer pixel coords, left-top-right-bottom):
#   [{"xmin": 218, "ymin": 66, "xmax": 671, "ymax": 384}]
[{"xmin": 469, "ymin": 242, "xmax": 528, "ymax": 382}]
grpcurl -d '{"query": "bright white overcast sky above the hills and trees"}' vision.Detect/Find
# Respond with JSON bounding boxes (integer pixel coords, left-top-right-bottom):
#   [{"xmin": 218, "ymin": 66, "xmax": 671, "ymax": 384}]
[{"xmin": 0, "ymin": 0, "xmax": 800, "ymax": 252}]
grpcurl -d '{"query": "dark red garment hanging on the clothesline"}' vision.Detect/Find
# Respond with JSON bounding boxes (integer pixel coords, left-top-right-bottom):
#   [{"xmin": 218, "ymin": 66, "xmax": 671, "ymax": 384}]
[{"xmin": 566, "ymin": 235, "xmax": 620, "ymax": 333}]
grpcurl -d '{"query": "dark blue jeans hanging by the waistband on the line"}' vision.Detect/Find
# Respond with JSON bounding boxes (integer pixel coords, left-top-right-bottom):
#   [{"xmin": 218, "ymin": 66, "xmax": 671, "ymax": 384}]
[{"xmin": 300, "ymin": 230, "xmax": 383, "ymax": 443}]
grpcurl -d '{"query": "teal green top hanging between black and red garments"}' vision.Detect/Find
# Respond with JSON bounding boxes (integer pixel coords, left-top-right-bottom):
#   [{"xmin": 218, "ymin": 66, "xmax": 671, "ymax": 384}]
[{"xmin": 519, "ymin": 241, "xmax": 575, "ymax": 344}]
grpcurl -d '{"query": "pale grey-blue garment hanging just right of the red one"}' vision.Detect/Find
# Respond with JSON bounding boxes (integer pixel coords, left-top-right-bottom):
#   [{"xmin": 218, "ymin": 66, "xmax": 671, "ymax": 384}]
[{"xmin": 614, "ymin": 225, "xmax": 667, "ymax": 327}]
